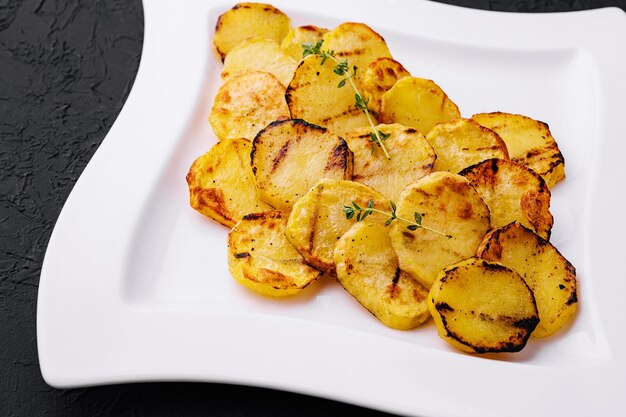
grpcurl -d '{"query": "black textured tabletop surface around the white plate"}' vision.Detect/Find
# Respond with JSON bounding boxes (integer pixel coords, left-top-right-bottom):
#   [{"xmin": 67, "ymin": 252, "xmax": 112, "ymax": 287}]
[{"xmin": 0, "ymin": 0, "xmax": 626, "ymax": 417}]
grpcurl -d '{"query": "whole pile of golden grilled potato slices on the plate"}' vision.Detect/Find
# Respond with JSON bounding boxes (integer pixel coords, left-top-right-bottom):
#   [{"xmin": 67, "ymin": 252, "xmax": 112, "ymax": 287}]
[{"xmin": 187, "ymin": 3, "xmax": 578, "ymax": 353}]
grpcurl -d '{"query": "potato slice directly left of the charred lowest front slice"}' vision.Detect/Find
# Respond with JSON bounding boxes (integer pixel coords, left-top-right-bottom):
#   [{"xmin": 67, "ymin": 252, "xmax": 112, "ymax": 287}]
[{"xmin": 334, "ymin": 222, "xmax": 430, "ymax": 330}]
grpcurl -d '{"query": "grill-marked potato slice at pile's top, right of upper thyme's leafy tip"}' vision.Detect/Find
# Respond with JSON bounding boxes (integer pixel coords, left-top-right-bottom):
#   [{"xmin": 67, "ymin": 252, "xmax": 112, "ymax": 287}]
[{"xmin": 323, "ymin": 22, "xmax": 391, "ymax": 79}]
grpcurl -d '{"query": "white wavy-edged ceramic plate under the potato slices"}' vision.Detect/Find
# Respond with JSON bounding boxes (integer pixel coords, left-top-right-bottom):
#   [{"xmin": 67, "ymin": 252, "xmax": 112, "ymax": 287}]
[{"xmin": 37, "ymin": 0, "xmax": 626, "ymax": 416}]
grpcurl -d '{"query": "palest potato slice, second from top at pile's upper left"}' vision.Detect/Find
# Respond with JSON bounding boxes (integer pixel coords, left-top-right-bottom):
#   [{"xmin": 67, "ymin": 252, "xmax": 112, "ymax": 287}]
[{"xmin": 222, "ymin": 38, "xmax": 298, "ymax": 85}]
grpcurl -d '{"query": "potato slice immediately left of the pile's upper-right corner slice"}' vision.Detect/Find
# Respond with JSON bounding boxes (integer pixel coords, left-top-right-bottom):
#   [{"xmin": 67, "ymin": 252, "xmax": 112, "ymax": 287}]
[{"xmin": 426, "ymin": 118, "xmax": 509, "ymax": 173}]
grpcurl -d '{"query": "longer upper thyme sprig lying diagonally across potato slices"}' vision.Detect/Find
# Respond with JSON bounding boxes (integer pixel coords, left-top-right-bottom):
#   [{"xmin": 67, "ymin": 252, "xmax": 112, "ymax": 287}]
[{"xmin": 302, "ymin": 40, "xmax": 391, "ymax": 159}]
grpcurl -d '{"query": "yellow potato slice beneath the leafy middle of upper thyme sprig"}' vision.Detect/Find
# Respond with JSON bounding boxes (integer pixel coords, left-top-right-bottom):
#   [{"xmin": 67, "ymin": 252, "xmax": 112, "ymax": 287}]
[{"xmin": 285, "ymin": 55, "xmax": 368, "ymax": 136}]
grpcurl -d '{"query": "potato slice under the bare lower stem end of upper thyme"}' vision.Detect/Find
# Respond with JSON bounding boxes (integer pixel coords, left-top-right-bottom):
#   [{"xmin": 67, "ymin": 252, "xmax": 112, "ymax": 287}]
[{"xmin": 346, "ymin": 124, "xmax": 436, "ymax": 200}]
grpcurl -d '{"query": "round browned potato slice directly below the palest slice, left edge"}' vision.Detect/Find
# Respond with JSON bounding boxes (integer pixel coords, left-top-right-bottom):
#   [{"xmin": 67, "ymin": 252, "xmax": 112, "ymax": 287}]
[{"xmin": 209, "ymin": 72, "xmax": 289, "ymax": 140}]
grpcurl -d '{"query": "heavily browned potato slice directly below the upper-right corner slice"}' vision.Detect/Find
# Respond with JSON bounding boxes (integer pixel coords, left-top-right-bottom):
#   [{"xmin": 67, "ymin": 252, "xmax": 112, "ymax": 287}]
[{"xmin": 460, "ymin": 159, "xmax": 554, "ymax": 240}]
